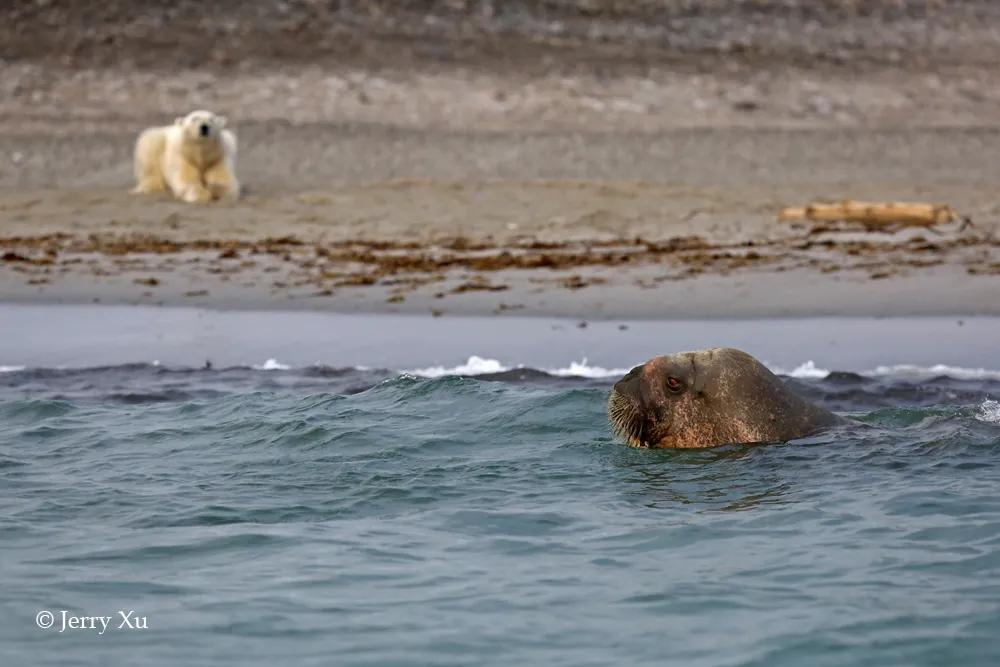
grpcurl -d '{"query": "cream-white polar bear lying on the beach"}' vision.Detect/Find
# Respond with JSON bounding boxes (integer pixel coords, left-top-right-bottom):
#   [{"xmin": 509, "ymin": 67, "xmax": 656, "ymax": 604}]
[{"xmin": 132, "ymin": 111, "xmax": 240, "ymax": 202}]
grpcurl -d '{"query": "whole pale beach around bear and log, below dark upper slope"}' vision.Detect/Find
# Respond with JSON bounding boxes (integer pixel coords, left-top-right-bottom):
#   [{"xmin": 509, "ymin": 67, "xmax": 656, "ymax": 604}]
[{"xmin": 0, "ymin": 3, "xmax": 1000, "ymax": 319}]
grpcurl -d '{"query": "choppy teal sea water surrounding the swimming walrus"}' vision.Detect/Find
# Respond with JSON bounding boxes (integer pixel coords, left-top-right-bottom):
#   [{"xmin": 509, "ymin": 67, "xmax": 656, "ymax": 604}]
[{"xmin": 0, "ymin": 364, "xmax": 1000, "ymax": 667}]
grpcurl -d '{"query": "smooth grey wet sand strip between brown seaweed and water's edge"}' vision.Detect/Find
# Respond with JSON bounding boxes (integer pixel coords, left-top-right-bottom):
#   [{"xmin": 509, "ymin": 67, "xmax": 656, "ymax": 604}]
[{"xmin": 0, "ymin": 266, "xmax": 1000, "ymax": 322}]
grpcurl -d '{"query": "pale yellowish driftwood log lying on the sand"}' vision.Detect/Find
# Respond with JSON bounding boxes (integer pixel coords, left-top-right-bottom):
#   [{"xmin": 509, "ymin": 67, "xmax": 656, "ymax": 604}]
[{"xmin": 778, "ymin": 200, "xmax": 955, "ymax": 229}]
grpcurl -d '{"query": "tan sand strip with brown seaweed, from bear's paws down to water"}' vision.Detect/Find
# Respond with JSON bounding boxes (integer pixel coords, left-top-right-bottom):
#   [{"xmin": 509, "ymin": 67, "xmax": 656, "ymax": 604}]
[{"xmin": 0, "ymin": 171, "xmax": 1000, "ymax": 319}]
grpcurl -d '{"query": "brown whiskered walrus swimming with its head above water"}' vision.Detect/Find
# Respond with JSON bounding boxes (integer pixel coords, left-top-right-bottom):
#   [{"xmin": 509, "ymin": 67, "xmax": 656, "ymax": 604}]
[{"xmin": 608, "ymin": 347, "xmax": 846, "ymax": 448}]
